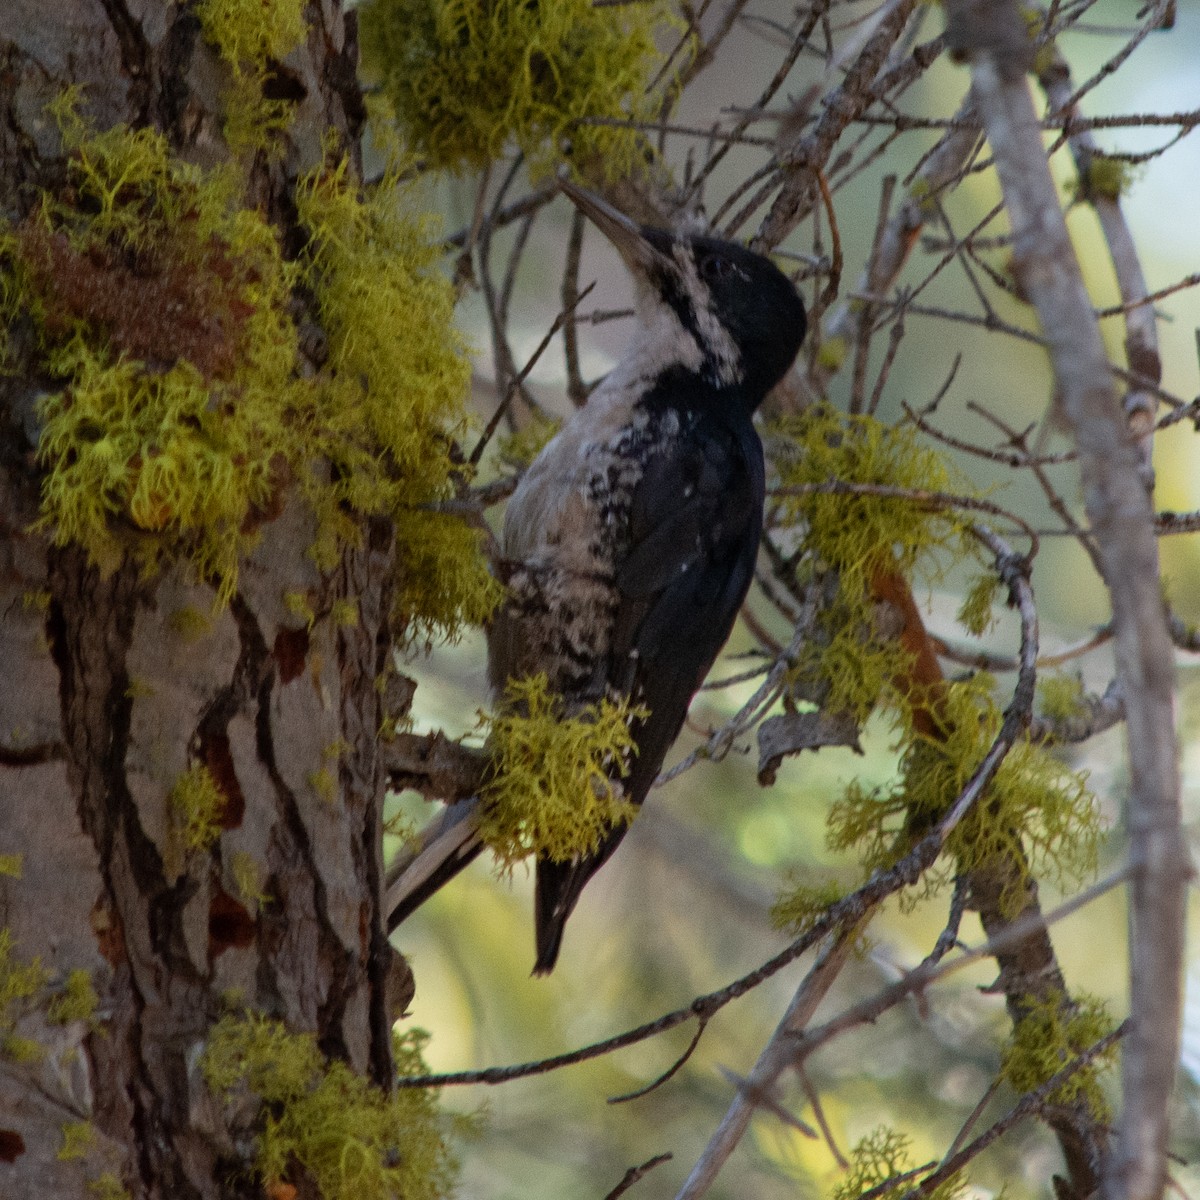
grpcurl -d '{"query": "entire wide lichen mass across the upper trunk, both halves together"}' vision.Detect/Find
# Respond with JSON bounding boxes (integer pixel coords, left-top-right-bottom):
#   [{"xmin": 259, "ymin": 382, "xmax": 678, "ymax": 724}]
[{"xmin": 0, "ymin": 103, "xmax": 499, "ymax": 635}]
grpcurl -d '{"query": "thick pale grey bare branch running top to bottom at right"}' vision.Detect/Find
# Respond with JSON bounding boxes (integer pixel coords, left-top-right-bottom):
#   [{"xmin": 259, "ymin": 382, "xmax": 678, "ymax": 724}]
[{"xmin": 949, "ymin": 0, "xmax": 1189, "ymax": 1200}]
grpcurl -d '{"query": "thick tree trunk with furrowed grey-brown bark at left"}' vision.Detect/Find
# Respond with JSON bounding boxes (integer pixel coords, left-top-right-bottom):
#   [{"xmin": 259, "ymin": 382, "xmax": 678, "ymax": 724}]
[{"xmin": 0, "ymin": 0, "xmax": 410, "ymax": 1200}]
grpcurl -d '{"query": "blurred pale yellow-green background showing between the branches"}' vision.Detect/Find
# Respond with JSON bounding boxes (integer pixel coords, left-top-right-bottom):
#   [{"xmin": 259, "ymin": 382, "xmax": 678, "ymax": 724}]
[{"xmin": 381, "ymin": 0, "xmax": 1200, "ymax": 1200}]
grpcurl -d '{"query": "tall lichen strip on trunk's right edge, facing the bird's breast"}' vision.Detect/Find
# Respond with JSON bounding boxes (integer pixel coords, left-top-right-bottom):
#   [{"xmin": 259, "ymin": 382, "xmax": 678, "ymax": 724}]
[{"xmin": 296, "ymin": 162, "xmax": 503, "ymax": 640}]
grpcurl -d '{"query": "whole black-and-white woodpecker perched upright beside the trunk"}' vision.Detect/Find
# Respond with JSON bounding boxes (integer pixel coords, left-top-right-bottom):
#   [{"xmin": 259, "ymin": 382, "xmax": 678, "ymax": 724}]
[{"xmin": 488, "ymin": 182, "xmax": 805, "ymax": 974}]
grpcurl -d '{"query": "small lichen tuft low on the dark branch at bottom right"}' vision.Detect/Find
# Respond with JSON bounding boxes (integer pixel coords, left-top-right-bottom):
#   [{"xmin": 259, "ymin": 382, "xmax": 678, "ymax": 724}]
[{"xmin": 1000, "ymin": 992, "xmax": 1116, "ymax": 1124}]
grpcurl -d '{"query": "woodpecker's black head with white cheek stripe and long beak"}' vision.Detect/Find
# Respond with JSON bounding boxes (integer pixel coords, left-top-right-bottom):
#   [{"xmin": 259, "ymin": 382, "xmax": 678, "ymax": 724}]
[{"xmin": 562, "ymin": 181, "xmax": 806, "ymax": 410}]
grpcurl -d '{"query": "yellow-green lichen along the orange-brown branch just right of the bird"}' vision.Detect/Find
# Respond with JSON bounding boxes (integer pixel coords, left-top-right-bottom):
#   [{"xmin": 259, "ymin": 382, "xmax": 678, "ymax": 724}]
[{"xmin": 773, "ymin": 406, "xmax": 1100, "ymax": 928}]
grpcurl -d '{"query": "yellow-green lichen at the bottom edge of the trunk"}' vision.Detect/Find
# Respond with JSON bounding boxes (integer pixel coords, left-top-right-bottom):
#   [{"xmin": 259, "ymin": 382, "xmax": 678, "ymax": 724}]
[{"xmin": 200, "ymin": 1014, "xmax": 455, "ymax": 1200}]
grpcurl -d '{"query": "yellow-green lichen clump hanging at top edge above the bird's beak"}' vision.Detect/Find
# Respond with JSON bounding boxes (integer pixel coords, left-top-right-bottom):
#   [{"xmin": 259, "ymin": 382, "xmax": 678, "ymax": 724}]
[{"xmin": 359, "ymin": 0, "xmax": 668, "ymax": 179}]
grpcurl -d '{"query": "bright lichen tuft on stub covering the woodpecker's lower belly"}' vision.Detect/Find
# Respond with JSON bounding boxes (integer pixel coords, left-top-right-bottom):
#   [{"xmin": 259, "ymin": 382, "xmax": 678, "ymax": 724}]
[{"xmin": 479, "ymin": 676, "xmax": 644, "ymax": 870}]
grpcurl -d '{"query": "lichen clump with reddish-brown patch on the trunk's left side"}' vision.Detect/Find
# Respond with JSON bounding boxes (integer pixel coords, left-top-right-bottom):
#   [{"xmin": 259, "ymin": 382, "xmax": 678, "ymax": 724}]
[{"xmin": 7, "ymin": 112, "xmax": 302, "ymax": 599}]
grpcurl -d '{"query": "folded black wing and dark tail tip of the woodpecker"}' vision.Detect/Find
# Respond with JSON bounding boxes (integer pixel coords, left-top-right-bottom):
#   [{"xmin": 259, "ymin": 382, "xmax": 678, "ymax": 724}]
[{"xmin": 534, "ymin": 420, "xmax": 764, "ymax": 974}]
